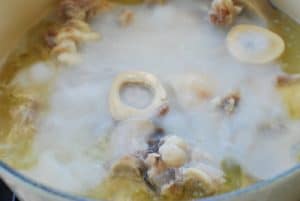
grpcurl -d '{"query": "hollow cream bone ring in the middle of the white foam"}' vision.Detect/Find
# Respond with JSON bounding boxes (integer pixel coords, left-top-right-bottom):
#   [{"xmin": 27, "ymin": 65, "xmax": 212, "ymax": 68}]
[{"xmin": 109, "ymin": 71, "xmax": 168, "ymax": 121}]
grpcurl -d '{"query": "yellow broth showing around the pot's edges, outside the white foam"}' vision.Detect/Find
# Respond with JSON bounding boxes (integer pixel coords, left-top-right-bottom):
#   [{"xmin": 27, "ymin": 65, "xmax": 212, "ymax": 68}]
[{"xmin": 0, "ymin": 0, "xmax": 300, "ymax": 201}]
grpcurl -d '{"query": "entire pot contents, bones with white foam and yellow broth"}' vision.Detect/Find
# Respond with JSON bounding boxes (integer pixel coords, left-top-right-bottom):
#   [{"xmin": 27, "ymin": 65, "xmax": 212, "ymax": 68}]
[{"xmin": 0, "ymin": 0, "xmax": 300, "ymax": 200}]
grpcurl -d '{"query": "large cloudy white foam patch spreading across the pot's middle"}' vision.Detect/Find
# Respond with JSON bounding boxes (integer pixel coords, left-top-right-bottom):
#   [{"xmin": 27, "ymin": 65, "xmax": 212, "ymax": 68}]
[{"xmin": 21, "ymin": 0, "xmax": 300, "ymax": 195}]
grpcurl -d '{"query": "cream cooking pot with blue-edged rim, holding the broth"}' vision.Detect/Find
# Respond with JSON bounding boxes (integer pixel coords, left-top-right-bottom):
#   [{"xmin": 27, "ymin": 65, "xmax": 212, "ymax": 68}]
[{"xmin": 0, "ymin": 0, "xmax": 300, "ymax": 201}]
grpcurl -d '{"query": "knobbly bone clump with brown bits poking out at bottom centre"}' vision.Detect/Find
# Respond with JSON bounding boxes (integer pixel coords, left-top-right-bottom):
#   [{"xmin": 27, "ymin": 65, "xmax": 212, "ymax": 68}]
[{"xmin": 111, "ymin": 131, "xmax": 223, "ymax": 199}]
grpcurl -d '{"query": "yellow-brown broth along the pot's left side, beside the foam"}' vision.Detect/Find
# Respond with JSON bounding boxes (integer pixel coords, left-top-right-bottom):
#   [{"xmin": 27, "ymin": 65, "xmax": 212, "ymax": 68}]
[{"xmin": 0, "ymin": 21, "xmax": 55, "ymax": 169}]
